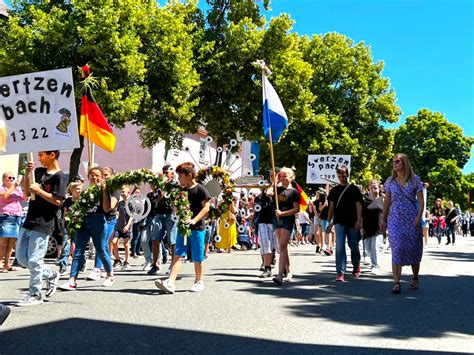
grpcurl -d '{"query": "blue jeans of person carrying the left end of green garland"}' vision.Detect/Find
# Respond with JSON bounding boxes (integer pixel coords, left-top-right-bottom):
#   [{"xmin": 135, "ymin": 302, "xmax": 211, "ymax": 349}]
[{"xmin": 71, "ymin": 213, "xmax": 112, "ymax": 279}]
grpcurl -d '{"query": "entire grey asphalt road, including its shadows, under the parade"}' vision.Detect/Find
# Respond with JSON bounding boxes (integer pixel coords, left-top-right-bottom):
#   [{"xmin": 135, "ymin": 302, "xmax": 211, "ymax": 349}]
[{"xmin": 0, "ymin": 237, "xmax": 474, "ymax": 355}]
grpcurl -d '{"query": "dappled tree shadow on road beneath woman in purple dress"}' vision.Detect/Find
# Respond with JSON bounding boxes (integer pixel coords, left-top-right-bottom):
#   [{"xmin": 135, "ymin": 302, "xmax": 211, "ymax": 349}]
[{"xmin": 237, "ymin": 271, "xmax": 474, "ymax": 339}]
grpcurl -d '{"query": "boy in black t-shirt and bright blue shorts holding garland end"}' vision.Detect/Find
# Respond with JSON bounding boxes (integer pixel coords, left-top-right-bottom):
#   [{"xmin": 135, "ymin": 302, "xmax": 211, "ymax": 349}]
[{"xmin": 155, "ymin": 163, "xmax": 211, "ymax": 293}]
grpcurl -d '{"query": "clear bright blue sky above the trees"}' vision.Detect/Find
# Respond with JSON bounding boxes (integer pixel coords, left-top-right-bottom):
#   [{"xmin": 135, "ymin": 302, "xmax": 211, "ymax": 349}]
[{"xmin": 264, "ymin": 0, "xmax": 474, "ymax": 173}]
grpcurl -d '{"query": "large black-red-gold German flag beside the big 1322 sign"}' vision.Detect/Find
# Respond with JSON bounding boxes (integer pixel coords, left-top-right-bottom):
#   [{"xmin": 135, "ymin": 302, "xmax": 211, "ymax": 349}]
[{"xmin": 80, "ymin": 90, "xmax": 115, "ymax": 153}]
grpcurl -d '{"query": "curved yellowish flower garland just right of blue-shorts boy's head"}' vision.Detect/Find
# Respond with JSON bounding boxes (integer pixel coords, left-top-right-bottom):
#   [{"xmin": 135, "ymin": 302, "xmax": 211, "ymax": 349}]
[{"xmin": 196, "ymin": 166, "xmax": 235, "ymax": 220}]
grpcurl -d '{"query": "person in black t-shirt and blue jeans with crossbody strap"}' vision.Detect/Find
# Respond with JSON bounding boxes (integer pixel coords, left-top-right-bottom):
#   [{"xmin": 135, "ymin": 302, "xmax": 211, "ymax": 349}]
[{"xmin": 326, "ymin": 165, "xmax": 364, "ymax": 282}]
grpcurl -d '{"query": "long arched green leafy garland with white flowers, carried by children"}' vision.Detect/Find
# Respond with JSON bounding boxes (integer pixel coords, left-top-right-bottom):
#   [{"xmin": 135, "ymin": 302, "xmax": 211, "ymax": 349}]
[{"xmin": 65, "ymin": 169, "xmax": 192, "ymax": 237}]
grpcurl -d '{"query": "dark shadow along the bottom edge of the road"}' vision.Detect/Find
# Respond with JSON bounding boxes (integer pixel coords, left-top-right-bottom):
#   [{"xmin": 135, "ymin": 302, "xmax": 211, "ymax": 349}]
[{"xmin": 0, "ymin": 318, "xmax": 452, "ymax": 355}]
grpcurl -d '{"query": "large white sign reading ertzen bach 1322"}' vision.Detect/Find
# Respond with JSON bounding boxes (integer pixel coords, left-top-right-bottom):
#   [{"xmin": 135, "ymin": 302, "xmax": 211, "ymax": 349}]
[{"xmin": 0, "ymin": 68, "xmax": 79, "ymax": 154}]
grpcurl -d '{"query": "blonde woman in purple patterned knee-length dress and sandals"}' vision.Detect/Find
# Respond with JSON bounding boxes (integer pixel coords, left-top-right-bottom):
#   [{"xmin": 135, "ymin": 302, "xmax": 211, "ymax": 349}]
[{"xmin": 380, "ymin": 153, "xmax": 425, "ymax": 294}]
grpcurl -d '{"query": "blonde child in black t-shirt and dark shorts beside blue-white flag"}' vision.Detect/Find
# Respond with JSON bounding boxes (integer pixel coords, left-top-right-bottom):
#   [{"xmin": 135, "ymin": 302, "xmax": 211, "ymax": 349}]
[{"xmin": 273, "ymin": 168, "xmax": 300, "ymax": 285}]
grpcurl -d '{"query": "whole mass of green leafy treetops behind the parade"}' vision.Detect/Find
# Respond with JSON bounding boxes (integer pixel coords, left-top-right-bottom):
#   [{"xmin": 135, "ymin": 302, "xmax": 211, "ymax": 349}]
[{"xmin": 0, "ymin": 0, "xmax": 473, "ymax": 209}]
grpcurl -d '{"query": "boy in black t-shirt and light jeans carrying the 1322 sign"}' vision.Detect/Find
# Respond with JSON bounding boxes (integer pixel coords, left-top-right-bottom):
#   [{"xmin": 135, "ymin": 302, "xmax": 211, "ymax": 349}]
[{"xmin": 16, "ymin": 150, "xmax": 67, "ymax": 306}]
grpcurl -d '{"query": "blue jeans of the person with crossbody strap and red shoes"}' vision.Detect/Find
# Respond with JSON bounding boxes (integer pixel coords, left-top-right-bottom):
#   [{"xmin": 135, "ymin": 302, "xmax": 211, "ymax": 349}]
[{"xmin": 335, "ymin": 224, "xmax": 360, "ymax": 275}]
